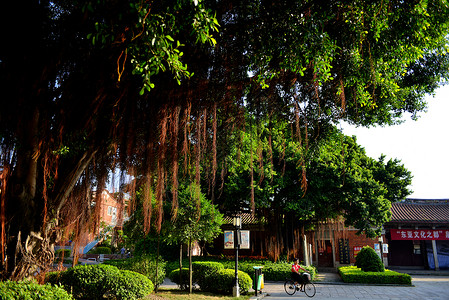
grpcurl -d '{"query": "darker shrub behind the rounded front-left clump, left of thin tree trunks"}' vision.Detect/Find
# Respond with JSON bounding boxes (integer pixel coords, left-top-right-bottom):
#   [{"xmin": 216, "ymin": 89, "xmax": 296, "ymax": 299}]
[{"xmin": 104, "ymin": 255, "xmax": 166, "ymax": 286}]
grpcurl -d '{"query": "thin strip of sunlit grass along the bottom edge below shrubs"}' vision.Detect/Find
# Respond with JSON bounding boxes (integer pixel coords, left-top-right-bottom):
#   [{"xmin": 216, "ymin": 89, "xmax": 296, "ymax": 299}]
[{"xmin": 143, "ymin": 288, "xmax": 254, "ymax": 300}]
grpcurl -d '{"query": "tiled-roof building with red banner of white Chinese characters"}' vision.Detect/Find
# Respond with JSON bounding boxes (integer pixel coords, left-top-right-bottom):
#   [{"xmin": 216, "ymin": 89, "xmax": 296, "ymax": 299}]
[{"xmin": 384, "ymin": 199, "xmax": 449, "ymax": 270}]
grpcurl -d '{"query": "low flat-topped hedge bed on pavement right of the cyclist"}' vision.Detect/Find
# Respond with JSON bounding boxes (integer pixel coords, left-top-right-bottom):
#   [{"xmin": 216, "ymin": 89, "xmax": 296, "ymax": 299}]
[{"xmin": 338, "ymin": 266, "xmax": 412, "ymax": 285}]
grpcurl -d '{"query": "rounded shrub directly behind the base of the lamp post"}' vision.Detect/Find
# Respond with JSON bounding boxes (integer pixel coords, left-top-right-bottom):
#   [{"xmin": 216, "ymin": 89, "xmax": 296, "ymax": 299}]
[{"xmin": 205, "ymin": 269, "xmax": 253, "ymax": 294}]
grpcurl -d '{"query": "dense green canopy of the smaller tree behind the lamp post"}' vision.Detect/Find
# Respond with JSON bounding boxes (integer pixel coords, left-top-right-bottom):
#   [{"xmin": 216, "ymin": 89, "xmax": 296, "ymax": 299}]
[{"xmin": 217, "ymin": 118, "xmax": 412, "ymax": 236}]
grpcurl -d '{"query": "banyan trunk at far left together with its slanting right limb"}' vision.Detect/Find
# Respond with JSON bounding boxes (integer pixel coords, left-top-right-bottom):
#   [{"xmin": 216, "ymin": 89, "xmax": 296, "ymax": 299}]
[{"xmin": 0, "ymin": 104, "xmax": 95, "ymax": 280}]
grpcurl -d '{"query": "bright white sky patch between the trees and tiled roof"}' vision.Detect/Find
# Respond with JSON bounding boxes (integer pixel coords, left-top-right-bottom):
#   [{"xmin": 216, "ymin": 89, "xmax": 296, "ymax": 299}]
[{"xmin": 342, "ymin": 85, "xmax": 449, "ymax": 199}]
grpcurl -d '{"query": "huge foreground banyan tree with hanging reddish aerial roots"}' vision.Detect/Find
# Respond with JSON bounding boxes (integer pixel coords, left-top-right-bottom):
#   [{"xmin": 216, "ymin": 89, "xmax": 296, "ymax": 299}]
[{"xmin": 0, "ymin": 0, "xmax": 449, "ymax": 279}]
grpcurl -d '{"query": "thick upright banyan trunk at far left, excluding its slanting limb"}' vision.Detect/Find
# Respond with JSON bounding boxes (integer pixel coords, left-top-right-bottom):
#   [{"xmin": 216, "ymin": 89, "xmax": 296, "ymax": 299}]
[{"xmin": 1, "ymin": 108, "xmax": 54, "ymax": 280}]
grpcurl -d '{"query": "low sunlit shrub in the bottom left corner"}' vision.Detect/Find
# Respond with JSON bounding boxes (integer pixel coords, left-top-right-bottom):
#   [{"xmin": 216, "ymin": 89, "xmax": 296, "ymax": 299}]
[{"xmin": 0, "ymin": 281, "xmax": 73, "ymax": 300}]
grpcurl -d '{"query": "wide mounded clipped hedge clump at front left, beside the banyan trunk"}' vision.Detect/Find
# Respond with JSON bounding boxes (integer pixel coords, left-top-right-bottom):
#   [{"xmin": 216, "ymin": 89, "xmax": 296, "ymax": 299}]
[{"xmin": 46, "ymin": 265, "xmax": 154, "ymax": 300}]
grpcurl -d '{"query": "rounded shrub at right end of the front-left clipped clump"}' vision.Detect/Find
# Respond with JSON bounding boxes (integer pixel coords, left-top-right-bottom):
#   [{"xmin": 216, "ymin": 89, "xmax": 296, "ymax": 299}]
[{"xmin": 108, "ymin": 270, "xmax": 154, "ymax": 299}]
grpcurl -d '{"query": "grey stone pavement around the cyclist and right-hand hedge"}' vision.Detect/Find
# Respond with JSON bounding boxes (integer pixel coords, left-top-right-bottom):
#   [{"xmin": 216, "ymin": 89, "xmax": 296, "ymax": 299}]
[{"xmin": 251, "ymin": 272, "xmax": 449, "ymax": 300}]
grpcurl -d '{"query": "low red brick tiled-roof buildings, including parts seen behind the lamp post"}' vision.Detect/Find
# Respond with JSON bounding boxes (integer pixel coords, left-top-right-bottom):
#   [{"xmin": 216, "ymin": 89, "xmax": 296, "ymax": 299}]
[{"xmin": 214, "ymin": 199, "xmax": 449, "ymax": 270}]
